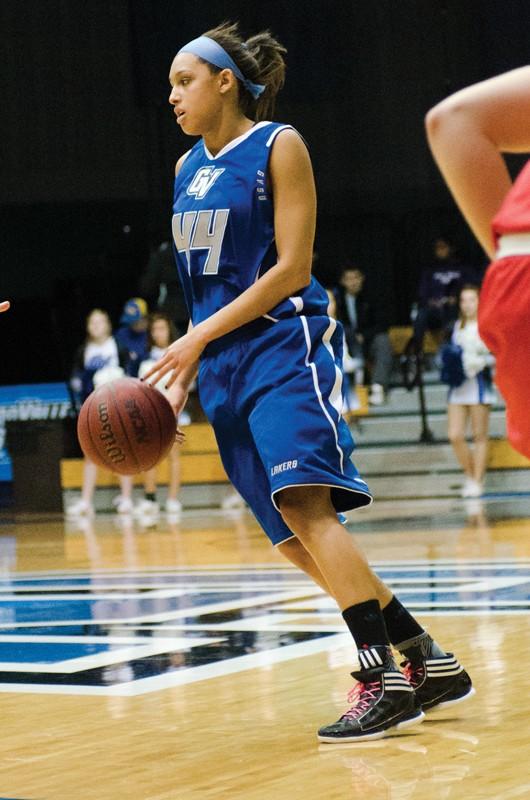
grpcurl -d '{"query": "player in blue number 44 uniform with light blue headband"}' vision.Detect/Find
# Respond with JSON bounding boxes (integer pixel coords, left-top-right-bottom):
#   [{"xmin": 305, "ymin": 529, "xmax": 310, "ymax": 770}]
[{"xmin": 146, "ymin": 20, "xmax": 472, "ymax": 742}]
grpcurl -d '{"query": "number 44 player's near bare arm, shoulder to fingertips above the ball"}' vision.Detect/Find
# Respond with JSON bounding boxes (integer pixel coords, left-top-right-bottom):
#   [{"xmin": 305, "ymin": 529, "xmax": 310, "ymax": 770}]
[{"xmin": 146, "ymin": 129, "xmax": 316, "ymax": 386}]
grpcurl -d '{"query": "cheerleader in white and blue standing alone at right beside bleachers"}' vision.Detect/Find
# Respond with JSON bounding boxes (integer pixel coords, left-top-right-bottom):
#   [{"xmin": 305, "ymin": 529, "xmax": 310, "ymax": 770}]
[{"xmin": 442, "ymin": 285, "xmax": 495, "ymax": 497}]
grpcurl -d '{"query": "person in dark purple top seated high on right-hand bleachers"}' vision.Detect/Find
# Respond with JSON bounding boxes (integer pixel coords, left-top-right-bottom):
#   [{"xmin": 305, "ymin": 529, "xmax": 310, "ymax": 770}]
[{"xmin": 412, "ymin": 237, "xmax": 480, "ymax": 350}]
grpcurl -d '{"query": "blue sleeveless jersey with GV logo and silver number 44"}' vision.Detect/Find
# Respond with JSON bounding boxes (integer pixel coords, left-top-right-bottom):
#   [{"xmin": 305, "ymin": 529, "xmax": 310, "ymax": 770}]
[{"xmin": 172, "ymin": 122, "xmax": 328, "ymax": 325}]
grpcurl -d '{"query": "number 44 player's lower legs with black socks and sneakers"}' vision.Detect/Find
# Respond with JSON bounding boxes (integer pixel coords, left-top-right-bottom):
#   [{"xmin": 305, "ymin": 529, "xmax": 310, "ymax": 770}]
[{"xmin": 279, "ymin": 486, "xmax": 473, "ymax": 742}]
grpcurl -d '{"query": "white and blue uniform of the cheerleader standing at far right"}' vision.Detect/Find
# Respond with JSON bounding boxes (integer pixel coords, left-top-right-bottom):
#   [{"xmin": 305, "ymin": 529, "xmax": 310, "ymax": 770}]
[{"xmin": 448, "ymin": 321, "xmax": 497, "ymax": 406}]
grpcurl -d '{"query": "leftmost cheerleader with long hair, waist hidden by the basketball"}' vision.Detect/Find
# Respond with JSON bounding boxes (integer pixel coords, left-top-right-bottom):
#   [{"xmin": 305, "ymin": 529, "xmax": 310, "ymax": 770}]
[{"xmin": 66, "ymin": 308, "xmax": 133, "ymax": 516}]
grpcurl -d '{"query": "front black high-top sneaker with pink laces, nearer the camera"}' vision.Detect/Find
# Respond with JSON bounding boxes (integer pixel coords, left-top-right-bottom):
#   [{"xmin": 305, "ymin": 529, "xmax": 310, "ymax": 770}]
[{"xmin": 318, "ymin": 646, "xmax": 425, "ymax": 742}]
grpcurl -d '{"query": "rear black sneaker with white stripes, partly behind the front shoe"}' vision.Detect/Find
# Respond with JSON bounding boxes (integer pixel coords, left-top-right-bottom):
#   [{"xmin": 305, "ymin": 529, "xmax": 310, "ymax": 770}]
[{"xmin": 401, "ymin": 653, "xmax": 475, "ymax": 711}]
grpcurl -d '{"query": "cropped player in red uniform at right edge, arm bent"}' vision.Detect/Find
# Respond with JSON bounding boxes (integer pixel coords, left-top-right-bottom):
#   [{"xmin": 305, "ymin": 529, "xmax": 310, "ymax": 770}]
[{"xmin": 426, "ymin": 67, "xmax": 530, "ymax": 456}]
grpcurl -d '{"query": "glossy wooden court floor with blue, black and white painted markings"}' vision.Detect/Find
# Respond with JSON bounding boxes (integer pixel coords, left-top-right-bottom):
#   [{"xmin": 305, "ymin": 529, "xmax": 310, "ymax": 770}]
[{"xmin": 0, "ymin": 496, "xmax": 530, "ymax": 800}]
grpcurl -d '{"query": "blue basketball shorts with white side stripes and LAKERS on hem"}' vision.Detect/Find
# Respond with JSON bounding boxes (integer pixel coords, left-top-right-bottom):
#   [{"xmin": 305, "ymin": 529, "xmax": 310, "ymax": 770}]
[{"xmin": 199, "ymin": 316, "xmax": 372, "ymax": 545}]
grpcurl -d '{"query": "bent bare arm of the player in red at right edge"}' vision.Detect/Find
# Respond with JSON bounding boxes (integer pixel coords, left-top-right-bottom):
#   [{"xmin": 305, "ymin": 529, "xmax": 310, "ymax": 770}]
[{"xmin": 426, "ymin": 67, "xmax": 530, "ymax": 256}]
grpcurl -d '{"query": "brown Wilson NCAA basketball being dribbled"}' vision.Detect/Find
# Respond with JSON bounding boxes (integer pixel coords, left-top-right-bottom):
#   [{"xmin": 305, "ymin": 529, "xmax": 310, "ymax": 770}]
[{"xmin": 77, "ymin": 378, "xmax": 176, "ymax": 475}]
